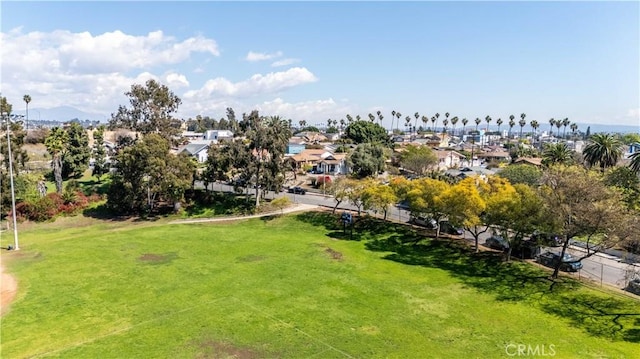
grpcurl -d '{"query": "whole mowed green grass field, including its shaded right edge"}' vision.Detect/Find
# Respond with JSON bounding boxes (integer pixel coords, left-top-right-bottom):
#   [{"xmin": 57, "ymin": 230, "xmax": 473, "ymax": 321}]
[{"xmin": 0, "ymin": 212, "xmax": 640, "ymax": 358}]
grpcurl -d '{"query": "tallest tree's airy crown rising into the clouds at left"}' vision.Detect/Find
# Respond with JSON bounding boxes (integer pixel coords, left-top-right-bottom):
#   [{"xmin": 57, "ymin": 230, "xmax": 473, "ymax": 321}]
[{"xmin": 109, "ymin": 80, "xmax": 182, "ymax": 140}]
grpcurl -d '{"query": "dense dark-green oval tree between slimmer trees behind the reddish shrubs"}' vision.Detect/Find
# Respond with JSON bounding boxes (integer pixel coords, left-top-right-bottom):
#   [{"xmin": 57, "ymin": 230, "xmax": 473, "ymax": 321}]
[{"xmin": 62, "ymin": 122, "xmax": 91, "ymax": 179}]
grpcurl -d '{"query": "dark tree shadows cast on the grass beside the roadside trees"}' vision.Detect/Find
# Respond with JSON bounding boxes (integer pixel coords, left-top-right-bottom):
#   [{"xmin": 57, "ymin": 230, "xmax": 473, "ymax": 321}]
[{"xmin": 297, "ymin": 212, "xmax": 640, "ymax": 343}]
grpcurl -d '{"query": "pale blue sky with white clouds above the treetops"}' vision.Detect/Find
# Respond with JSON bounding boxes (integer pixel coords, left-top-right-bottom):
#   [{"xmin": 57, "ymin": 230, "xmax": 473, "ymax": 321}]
[{"xmin": 0, "ymin": 1, "xmax": 640, "ymax": 129}]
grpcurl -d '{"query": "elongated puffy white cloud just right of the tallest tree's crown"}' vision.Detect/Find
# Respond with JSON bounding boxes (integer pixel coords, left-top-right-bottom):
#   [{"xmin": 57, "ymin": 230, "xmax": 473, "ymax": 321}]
[{"xmin": 184, "ymin": 67, "xmax": 318, "ymax": 100}]
